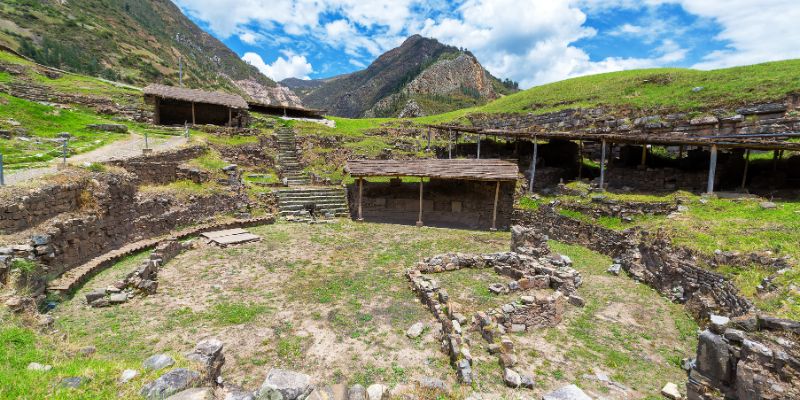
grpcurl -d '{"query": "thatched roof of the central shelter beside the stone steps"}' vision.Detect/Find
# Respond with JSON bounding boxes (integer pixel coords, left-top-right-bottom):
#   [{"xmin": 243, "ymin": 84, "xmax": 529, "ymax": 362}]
[{"xmin": 345, "ymin": 159, "xmax": 519, "ymax": 181}]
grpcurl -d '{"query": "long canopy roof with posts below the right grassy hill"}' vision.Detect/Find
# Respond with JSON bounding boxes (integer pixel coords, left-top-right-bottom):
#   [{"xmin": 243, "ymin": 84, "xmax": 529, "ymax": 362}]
[{"xmin": 428, "ymin": 125, "xmax": 800, "ymax": 193}]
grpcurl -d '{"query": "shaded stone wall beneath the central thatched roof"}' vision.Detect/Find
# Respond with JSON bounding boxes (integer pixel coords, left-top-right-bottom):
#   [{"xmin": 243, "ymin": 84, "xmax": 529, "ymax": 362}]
[{"xmin": 347, "ymin": 179, "xmax": 515, "ymax": 229}]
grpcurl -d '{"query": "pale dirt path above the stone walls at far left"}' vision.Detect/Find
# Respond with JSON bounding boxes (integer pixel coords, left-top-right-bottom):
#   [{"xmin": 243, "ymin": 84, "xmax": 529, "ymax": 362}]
[{"xmin": 5, "ymin": 133, "xmax": 186, "ymax": 185}]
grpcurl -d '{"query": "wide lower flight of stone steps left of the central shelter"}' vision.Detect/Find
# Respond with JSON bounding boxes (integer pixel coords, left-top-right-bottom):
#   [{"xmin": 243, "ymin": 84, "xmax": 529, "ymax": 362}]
[{"xmin": 277, "ymin": 187, "xmax": 350, "ymax": 218}]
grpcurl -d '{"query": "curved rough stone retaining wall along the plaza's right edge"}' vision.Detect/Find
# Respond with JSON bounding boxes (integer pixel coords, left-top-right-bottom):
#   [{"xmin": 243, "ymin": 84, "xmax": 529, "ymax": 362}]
[{"xmin": 514, "ymin": 206, "xmax": 753, "ymax": 319}]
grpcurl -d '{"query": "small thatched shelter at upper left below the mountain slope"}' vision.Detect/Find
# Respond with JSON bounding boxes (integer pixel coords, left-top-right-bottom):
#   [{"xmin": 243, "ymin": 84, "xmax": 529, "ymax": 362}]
[{"xmin": 144, "ymin": 84, "xmax": 248, "ymax": 127}]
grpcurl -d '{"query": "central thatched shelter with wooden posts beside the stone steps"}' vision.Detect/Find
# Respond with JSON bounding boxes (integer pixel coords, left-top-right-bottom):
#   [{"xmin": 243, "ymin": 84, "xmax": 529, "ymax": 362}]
[{"xmin": 345, "ymin": 159, "xmax": 519, "ymax": 230}]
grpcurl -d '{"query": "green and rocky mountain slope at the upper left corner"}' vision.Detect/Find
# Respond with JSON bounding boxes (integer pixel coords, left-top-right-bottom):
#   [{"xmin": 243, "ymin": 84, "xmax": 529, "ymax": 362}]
[{"xmin": 0, "ymin": 0, "xmax": 298, "ymax": 103}]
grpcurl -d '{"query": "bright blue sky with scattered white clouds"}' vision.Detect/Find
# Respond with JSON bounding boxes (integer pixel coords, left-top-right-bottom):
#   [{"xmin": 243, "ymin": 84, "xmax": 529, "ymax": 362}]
[{"xmin": 173, "ymin": 0, "xmax": 800, "ymax": 88}]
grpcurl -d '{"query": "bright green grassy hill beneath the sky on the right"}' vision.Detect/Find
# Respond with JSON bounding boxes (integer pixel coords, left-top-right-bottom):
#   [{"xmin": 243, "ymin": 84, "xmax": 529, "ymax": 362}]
[{"xmin": 417, "ymin": 60, "xmax": 800, "ymax": 123}]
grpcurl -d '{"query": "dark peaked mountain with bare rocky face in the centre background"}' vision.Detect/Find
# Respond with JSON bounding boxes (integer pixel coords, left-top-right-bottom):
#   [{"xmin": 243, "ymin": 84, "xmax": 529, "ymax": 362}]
[{"xmin": 296, "ymin": 35, "xmax": 514, "ymax": 117}]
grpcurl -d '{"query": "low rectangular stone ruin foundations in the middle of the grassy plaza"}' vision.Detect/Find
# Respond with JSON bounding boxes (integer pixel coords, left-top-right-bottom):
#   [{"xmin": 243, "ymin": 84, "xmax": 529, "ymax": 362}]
[{"xmin": 406, "ymin": 226, "xmax": 584, "ymax": 388}]
